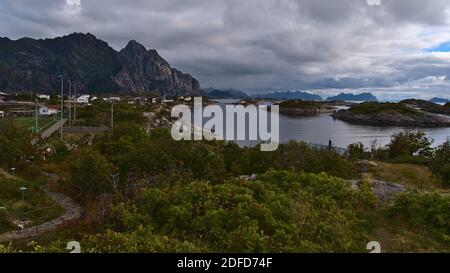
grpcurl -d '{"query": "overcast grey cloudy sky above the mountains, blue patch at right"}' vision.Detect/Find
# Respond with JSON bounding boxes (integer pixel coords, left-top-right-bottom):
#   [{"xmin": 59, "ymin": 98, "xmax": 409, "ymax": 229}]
[{"xmin": 0, "ymin": 0, "xmax": 450, "ymax": 99}]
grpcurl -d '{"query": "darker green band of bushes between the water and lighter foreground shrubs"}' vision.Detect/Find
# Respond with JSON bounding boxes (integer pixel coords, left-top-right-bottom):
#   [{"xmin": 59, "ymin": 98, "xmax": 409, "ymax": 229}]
[{"xmin": 62, "ymin": 123, "xmax": 355, "ymax": 198}]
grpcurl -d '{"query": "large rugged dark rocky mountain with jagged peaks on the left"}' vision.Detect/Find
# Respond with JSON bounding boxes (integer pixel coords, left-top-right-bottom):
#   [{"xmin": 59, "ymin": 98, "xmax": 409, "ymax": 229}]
[{"xmin": 0, "ymin": 33, "xmax": 201, "ymax": 96}]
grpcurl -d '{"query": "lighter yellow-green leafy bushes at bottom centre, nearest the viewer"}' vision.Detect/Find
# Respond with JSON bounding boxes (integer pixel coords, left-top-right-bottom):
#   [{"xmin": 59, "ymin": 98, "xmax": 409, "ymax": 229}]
[{"xmin": 95, "ymin": 171, "xmax": 375, "ymax": 252}]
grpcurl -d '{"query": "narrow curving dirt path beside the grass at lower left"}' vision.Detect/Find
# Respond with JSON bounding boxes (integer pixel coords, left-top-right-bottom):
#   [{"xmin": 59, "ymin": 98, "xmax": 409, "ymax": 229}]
[{"xmin": 0, "ymin": 189, "xmax": 81, "ymax": 242}]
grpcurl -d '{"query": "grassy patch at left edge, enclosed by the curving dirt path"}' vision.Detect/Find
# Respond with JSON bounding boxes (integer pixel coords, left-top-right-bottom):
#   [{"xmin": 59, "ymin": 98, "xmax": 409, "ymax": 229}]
[{"xmin": 0, "ymin": 170, "xmax": 63, "ymax": 233}]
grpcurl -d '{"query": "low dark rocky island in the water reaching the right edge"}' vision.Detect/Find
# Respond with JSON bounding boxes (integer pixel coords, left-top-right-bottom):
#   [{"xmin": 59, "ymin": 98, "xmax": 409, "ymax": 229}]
[{"xmin": 332, "ymin": 102, "xmax": 450, "ymax": 128}]
